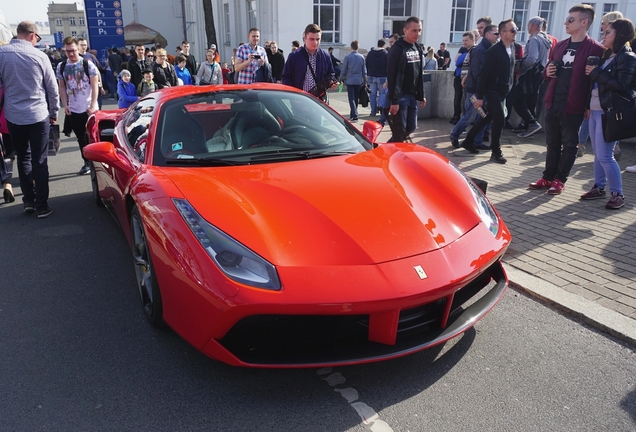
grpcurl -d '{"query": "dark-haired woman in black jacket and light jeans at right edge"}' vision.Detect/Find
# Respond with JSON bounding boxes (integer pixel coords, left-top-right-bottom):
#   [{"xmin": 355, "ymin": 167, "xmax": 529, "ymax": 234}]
[{"xmin": 581, "ymin": 19, "xmax": 636, "ymax": 209}]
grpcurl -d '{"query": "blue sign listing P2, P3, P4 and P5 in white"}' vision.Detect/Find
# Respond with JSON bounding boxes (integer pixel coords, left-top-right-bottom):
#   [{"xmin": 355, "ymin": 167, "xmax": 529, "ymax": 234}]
[{"xmin": 84, "ymin": 0, "xmax": 126, "ymax": 61}]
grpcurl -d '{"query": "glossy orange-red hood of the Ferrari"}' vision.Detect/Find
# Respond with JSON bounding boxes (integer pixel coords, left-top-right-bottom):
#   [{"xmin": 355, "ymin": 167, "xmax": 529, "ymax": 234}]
[{"xmin": 162, "ymin": 144, "xmax": 481, "ymax": 266}]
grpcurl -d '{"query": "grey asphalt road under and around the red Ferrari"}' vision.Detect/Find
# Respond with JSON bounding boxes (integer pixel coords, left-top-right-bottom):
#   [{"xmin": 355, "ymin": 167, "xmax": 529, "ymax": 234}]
[{"xmin": 0, "ymin": 132, "xmax": 636, "ymax": 432}]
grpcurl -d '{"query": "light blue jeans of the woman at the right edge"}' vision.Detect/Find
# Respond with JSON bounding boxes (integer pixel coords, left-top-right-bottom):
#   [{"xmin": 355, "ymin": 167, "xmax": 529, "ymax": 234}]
[{"xmin": 590, "ymin": 110, "xmax": 623, "ymax": 195}]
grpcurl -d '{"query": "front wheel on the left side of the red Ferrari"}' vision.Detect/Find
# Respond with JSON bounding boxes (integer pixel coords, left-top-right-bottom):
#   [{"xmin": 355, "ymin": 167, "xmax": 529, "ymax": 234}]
[{"xmin": 130, "ymin": 206, "xmax": 165, "ymax": 327}]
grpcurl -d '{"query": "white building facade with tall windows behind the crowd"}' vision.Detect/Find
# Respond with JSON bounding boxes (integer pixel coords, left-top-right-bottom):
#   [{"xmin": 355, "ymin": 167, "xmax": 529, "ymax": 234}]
[{"xmin": 122, "ymin": 0, "xmax": 636, "ymax": 67}]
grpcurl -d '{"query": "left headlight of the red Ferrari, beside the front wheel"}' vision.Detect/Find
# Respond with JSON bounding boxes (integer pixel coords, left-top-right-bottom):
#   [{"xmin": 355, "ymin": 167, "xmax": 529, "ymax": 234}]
[{"xmin": 172, "ymin": 199, "xmax": 280, "ymax": 290}]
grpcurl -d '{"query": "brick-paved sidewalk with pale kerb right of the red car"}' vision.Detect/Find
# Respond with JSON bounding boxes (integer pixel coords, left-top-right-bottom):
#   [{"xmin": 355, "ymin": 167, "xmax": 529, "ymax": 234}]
[{"xmin": 330, "ymin": 89, "xmax": 636, "ymax": 344}]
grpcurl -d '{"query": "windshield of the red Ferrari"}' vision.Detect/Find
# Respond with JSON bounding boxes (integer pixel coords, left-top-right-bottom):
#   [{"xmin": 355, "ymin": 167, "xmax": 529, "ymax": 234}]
[{"xmin": 154, "ymin": 89, "xmax": 372, "ymax": 166}]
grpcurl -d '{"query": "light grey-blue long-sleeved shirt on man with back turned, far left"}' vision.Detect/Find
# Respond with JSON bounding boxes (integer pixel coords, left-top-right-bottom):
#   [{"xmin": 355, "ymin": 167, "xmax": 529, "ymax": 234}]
[{"xmin": 0, "ymin": 39, "xmax": 60, "ymax": 125}]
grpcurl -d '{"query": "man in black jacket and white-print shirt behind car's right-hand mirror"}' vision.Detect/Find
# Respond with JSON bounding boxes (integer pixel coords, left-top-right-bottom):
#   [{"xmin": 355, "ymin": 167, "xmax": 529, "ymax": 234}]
[{"xmin": 387, "ymin": 17, "xmax": 426, "ymax": 142}]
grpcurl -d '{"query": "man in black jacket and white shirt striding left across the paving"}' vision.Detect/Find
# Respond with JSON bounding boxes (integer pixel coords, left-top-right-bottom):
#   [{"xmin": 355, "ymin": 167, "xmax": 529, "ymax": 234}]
[{"xmin": 461, "ymin": 19, "xmax": 518, "ymax": 164}]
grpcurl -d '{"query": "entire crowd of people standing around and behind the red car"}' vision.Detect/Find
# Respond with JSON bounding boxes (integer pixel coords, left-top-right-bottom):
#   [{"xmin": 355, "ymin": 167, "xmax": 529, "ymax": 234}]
[{"xmin": 0, "ymin": 4, "xmax": 636, "ymax": 218}]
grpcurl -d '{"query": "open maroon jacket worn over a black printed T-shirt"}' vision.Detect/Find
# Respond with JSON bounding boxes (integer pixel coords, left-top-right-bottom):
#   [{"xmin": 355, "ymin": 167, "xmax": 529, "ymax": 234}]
[{"xmin": 543, "ymin": 36, "xmax": 605, "ymax": 114}]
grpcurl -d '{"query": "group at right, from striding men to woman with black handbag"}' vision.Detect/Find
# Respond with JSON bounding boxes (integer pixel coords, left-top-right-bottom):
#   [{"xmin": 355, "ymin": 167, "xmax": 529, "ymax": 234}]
[{"xmin": 440, "ymin": 4, "xmax": 636, "ymax": 209}]
